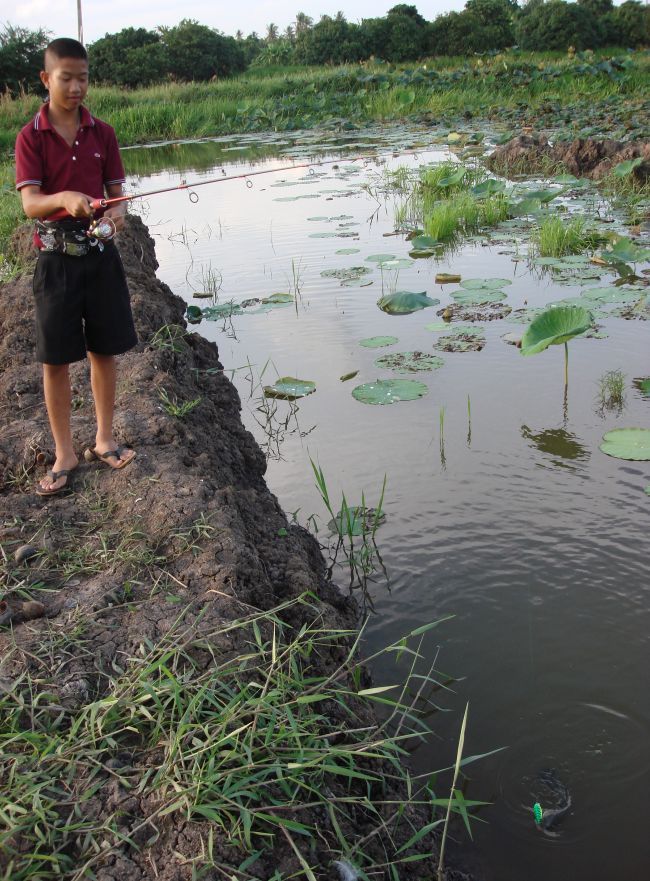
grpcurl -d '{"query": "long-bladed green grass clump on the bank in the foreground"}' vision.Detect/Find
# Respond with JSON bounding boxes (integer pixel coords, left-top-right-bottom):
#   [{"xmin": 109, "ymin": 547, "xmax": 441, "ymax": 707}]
[{"xmin": 0, "ymin": 595, "xmax": 478, "ymax": 881}]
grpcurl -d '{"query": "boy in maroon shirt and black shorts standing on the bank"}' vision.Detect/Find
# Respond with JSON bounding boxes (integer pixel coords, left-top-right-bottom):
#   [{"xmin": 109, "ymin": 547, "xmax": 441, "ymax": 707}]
[{"xmin": 16, "ymin": 38, "xmax": 137, "ymax": 496}]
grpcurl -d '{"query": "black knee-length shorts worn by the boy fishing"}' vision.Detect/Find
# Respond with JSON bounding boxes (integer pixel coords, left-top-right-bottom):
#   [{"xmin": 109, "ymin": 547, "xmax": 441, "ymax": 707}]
[{"xmin": 34, "ymin": 242, "xmax": 138, "ymax": 364}]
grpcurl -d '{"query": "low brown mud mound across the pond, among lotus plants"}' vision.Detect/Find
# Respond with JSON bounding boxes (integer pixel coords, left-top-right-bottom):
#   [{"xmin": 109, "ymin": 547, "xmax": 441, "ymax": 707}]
[{"xmin": 487, "ymin": 132, "xmax": 650, "ymax": 182}]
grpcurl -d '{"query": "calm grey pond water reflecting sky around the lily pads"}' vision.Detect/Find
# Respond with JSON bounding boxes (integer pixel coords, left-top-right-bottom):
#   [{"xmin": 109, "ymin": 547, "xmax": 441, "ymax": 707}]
[{"xmin": 123, "ymin": 128, "xmax": 650, "ymax": 881}]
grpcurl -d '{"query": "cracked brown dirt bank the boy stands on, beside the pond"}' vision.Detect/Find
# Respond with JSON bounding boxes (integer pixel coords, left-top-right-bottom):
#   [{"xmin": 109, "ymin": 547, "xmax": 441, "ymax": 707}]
[{"xmin": 0, "ymin": 218, "xmax": 464, "ymax": 881}]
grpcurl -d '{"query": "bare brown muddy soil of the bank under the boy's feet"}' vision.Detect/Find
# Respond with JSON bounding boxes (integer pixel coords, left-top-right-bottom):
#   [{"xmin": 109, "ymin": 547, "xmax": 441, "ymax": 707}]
[{"xmin": 0, "ymin": 218, "xmax": 465, "ymax": 881}]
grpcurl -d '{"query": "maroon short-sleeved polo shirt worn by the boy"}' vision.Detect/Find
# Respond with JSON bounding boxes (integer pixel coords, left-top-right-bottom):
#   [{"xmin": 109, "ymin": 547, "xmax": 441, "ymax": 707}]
[{"xmin": 16, "ymin": 103, "xmax": 125, "ymax": 217}]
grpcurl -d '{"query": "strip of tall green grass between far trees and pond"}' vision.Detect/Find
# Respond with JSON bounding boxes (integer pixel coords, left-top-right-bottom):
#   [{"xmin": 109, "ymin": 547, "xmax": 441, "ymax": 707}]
[{"xmin": 0, "ymin": 50, "xmax": 650, "ymax": 152}]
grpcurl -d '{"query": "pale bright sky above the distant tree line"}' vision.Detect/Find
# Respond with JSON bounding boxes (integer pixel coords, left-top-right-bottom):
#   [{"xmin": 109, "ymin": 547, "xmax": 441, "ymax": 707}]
[{"xmin": 8, "ymin": 0, "xmax": 465, "ymax": 43}]
